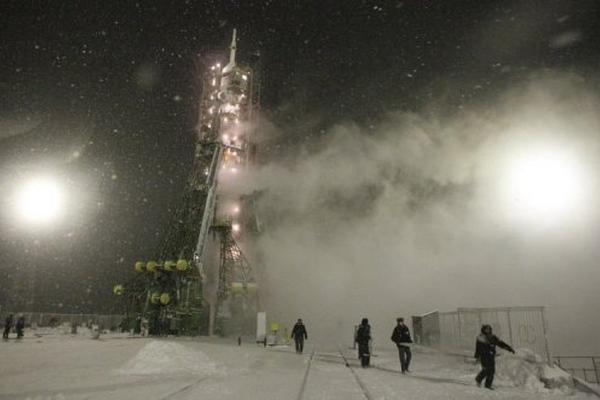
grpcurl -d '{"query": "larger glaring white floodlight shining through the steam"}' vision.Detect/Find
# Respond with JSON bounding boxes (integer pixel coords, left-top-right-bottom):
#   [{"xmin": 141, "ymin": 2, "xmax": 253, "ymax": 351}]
[{"xmin": 496, "ymin": 148, "xmax": 584, "ymax": 222}]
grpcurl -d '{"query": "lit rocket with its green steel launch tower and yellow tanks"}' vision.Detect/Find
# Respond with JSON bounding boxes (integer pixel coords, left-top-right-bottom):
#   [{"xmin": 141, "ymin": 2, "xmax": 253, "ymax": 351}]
[{"xmin": 114, "ymin": 29, "xmax": 260, "ymax": 336}]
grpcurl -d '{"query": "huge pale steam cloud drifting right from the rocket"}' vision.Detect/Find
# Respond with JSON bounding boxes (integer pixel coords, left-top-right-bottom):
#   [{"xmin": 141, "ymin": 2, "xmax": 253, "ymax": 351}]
[{"xmin": 244, "ymin": 72, "xmax": 600, "ymax": 354}]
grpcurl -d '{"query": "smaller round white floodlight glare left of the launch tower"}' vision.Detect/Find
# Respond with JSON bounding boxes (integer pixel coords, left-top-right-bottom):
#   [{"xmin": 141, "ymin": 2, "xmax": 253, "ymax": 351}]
[{"xmin": 15, "ymin": 178, "xmax": 63, "ymax": 224}]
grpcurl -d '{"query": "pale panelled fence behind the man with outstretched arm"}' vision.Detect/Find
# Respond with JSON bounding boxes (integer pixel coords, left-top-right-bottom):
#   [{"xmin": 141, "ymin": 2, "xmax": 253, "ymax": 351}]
[{"xmin": 413, "ymin": 307, "xmax": 550, "ymax": 361}]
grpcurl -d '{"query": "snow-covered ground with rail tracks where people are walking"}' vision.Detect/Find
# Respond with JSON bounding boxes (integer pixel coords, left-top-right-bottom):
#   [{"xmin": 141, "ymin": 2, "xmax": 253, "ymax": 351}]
[{"xmin": 0, "ymin": 332, "xmax": 596, "ymax": 400}]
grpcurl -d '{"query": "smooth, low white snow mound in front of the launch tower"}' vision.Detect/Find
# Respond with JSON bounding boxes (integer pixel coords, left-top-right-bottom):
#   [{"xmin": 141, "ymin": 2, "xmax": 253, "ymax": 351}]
[{"xmin": 117, "ymin": 340, "xmax": 218, "ymax": 376}]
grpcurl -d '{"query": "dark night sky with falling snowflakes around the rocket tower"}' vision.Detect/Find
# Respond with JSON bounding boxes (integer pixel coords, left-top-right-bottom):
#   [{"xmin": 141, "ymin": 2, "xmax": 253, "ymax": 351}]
[{"xmin": 0, "ymin": 0, "xmax": 600, "ymax": 312}]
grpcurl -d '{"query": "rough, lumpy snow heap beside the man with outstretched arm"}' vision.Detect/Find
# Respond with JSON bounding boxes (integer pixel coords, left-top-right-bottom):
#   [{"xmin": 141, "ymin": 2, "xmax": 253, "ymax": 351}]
[{"xmin": 497, "ymin": 349, "xmax": 574, "ymax": 394}]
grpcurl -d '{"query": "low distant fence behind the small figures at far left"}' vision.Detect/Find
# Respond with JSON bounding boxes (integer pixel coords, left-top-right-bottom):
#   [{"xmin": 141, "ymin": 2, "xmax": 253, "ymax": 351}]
[{"xmin": 2, "ymin": 312, "xmax": 123, "ymax": 330}]
